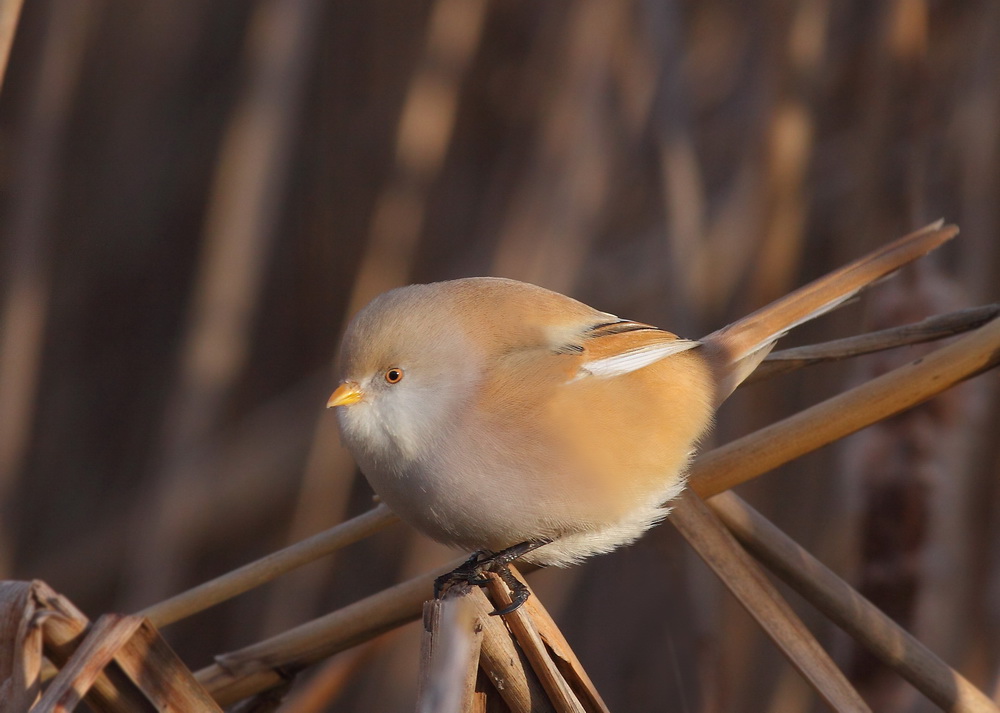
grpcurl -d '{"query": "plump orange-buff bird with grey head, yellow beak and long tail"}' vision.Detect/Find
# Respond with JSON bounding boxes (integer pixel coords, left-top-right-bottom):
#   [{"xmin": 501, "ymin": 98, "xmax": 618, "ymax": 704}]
[{"xmin": 327, "ymin": 221, "xmax": 958, "ymax": 613}]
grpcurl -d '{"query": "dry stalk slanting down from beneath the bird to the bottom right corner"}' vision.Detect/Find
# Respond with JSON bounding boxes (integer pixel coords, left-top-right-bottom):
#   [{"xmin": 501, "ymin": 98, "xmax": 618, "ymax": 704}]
[{"xmin": 708, "ymin": 492, "xmax": 1000, "ymax": 713}]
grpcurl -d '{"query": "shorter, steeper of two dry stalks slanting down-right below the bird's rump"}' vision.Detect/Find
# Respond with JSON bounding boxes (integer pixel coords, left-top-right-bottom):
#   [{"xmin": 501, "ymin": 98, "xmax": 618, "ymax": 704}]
[{"xmin": 668, "ymin": 491, "xmax": 870, "ymax": 711}]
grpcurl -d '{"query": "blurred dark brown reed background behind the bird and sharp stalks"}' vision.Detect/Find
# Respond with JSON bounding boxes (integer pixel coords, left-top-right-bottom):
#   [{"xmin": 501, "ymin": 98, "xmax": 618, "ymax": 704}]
[{"xmin": 0, "ymin": 0, "xmax": 1000, "ymax": 713}]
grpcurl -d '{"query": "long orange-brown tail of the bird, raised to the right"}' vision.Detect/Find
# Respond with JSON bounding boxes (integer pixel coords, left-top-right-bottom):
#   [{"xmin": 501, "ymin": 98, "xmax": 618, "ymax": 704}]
[{"xmin": 701, "ymin": 221, "xmax": 958, "ymax": 404}]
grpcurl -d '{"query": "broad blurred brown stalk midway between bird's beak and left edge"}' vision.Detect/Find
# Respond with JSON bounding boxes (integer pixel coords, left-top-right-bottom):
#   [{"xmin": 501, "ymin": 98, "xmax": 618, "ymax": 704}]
[{"xmin": 120, "ymin": 0, "xmax": 322, "ymax": 608}]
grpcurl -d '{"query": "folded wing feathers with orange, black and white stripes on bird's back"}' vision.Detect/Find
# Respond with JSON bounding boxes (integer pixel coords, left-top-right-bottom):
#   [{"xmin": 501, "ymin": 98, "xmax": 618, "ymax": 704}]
[{"xmin": 574, "ymin": 320, "xmax": 700, "ymax": 378}]
